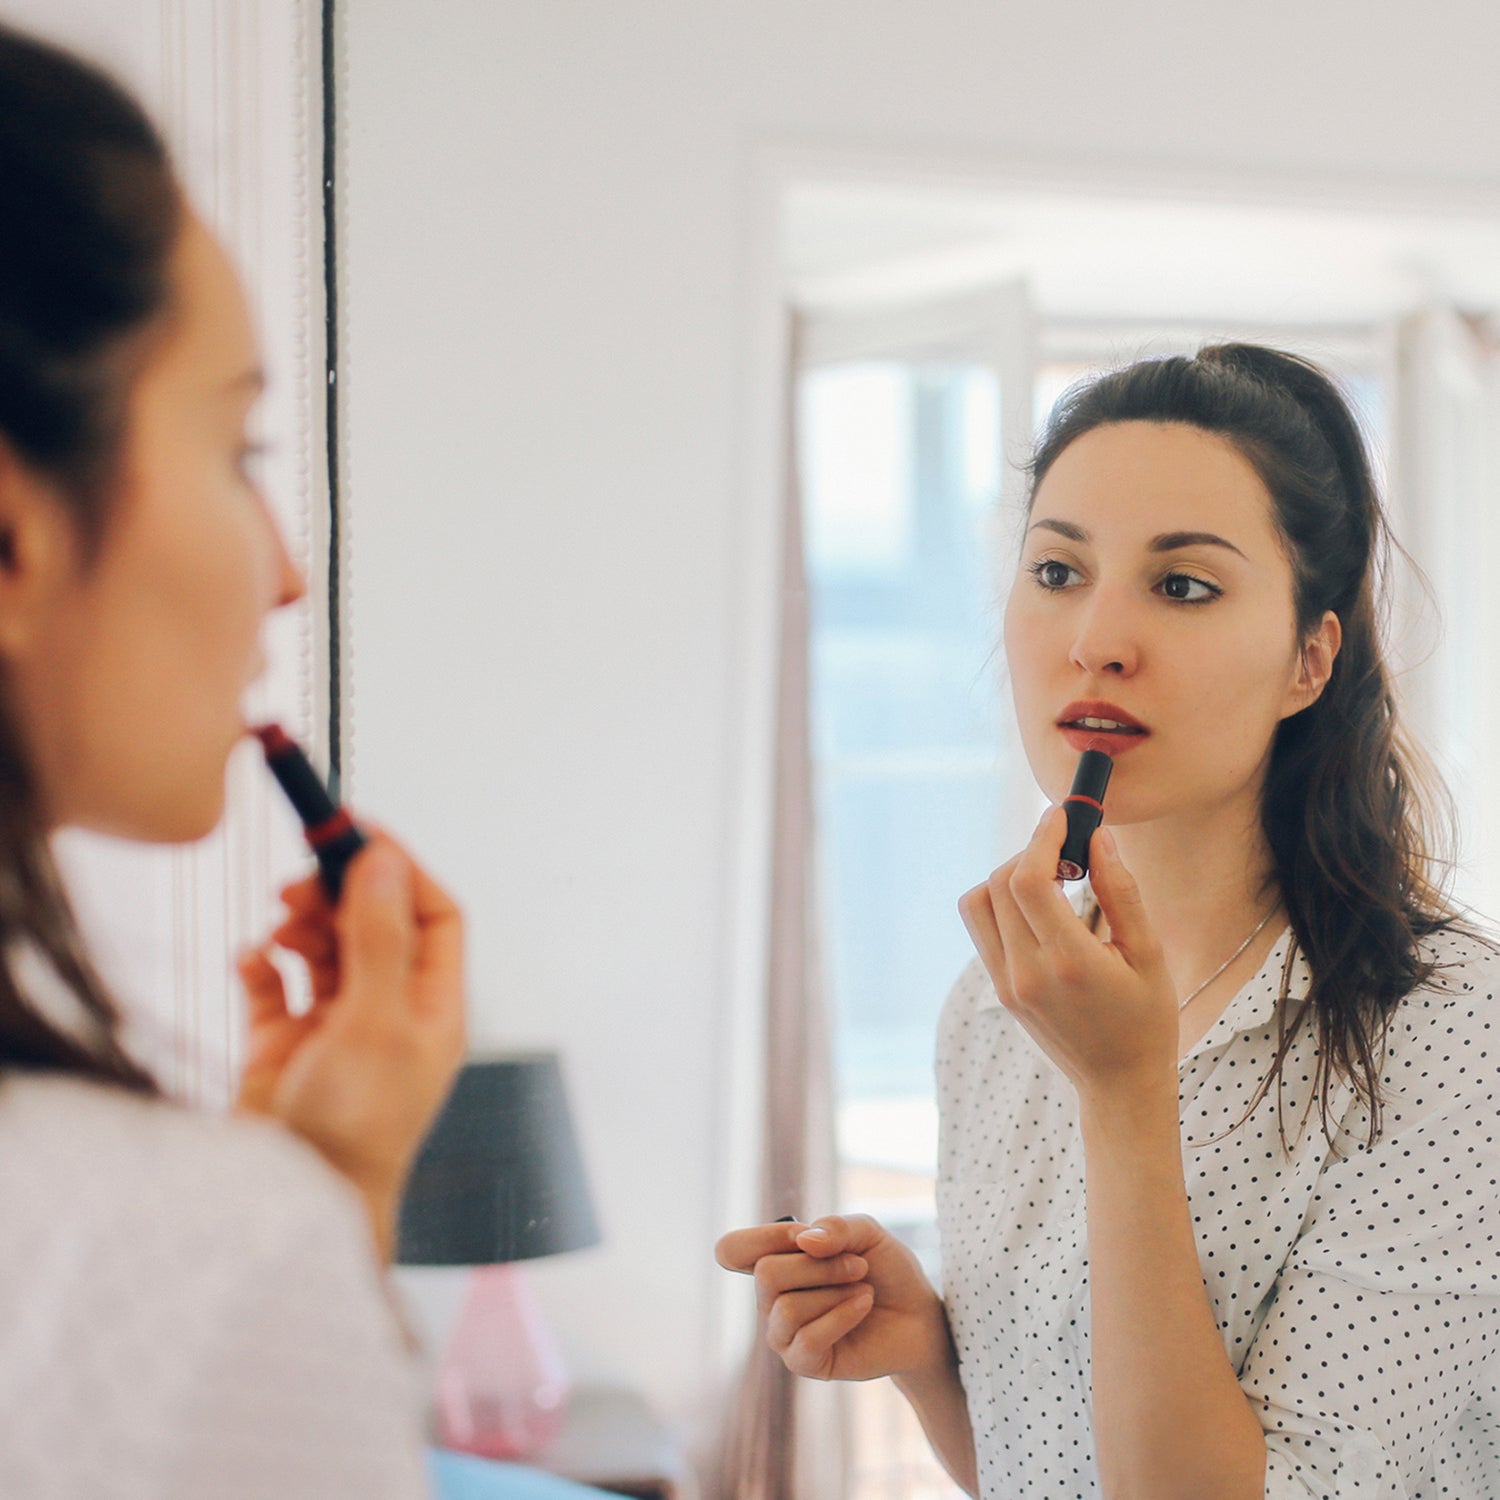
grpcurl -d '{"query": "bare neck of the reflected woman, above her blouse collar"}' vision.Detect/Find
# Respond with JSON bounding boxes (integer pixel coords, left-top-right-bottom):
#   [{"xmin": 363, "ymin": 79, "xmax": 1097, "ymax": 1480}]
[{"xmin": 1113, "ymin": 803, "xmax": 1280, "ymax": 996}]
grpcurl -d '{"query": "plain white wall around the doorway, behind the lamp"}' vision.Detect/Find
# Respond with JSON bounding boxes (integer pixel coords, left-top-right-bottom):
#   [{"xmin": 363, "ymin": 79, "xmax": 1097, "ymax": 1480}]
[{"xmin": 339, "ymin": 0, "xmax": 1500, "ymax": 1452}]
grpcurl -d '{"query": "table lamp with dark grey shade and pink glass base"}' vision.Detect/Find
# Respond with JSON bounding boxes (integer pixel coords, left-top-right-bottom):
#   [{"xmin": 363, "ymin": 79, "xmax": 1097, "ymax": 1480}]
[{"xmin": 396, "ymin": 1053, "xmax": 600, "ymax": 1458}]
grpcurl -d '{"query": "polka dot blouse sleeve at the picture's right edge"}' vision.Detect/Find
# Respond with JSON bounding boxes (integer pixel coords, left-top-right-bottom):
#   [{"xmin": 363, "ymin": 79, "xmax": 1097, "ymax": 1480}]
[{"xmin": 1241, "ymin": 1001, "xmax": 1500, "ymax": 1500}]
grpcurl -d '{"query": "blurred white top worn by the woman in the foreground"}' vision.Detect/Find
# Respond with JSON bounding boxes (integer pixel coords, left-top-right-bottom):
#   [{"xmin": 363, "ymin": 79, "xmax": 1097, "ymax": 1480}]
[{"xmin": 0, "ymin": 1074, "xmax": 420, "ymax": 1500}]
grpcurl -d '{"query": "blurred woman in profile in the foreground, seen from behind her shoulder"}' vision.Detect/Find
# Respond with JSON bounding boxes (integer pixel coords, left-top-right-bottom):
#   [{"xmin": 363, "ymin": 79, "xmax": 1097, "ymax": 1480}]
[{"xmin": 0, "ymin": 29, "xmax": 464, "ymax": 1500}]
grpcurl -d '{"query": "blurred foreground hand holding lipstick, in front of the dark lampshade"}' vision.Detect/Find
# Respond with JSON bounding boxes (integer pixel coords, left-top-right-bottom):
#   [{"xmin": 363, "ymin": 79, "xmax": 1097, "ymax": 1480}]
[{"xmin": 239, "ymin": 834, "xmax": 464, "ymax": 1260}]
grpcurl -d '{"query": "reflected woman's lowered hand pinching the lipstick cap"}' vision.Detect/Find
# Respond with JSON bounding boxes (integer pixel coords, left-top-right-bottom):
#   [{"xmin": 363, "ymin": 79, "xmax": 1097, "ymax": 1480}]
[{"xmin": 714, "ymin": 1214, "xmax": 953, "ymax": 1380}]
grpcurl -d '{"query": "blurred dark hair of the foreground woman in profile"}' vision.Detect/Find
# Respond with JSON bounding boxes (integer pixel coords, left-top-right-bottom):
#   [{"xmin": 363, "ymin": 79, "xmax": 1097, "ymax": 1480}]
[{"xmin": 0, "ymin": 26, "xmax": 183, "ymax": 1092}]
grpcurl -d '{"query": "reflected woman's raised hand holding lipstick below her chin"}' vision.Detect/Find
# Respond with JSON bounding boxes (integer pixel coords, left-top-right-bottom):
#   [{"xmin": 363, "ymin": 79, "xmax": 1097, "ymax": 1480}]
[{"xmin": 959, "ymin": 807, "xmax": 1178, "ymax": 1097}]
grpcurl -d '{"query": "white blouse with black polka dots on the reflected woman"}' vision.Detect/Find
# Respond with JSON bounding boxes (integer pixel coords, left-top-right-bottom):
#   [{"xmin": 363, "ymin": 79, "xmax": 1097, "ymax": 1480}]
[{"xmin": 938, "ymin": 933, "xmax": 1500, "ymax": 1500}]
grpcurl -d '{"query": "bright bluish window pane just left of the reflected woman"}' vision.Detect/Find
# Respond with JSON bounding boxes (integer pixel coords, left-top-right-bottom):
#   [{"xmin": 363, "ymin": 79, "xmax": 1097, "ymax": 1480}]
[{"xmin": 800, "ymin": 362, "xmax": 1004, "ymax": 1500}]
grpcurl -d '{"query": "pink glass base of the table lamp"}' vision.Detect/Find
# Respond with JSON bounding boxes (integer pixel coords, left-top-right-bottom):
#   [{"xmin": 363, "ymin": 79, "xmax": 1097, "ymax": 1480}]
[{"xmin": 438, "ymin": 1265, "xmax": 570, "ymax": 1460}]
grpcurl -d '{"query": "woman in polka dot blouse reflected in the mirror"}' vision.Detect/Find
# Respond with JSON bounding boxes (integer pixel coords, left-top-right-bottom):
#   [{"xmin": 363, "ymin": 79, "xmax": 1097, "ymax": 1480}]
[{"xmin": 719, "ymin": 345, "xmax": 1500, "ymax": 1500}]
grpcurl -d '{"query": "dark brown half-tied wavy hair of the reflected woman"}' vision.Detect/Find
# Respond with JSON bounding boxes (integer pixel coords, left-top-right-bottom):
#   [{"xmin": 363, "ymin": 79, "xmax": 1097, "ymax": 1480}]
[{"xmin": 1032, "ymin": 344, "xmax": 1457, "ymax": 1143}]
